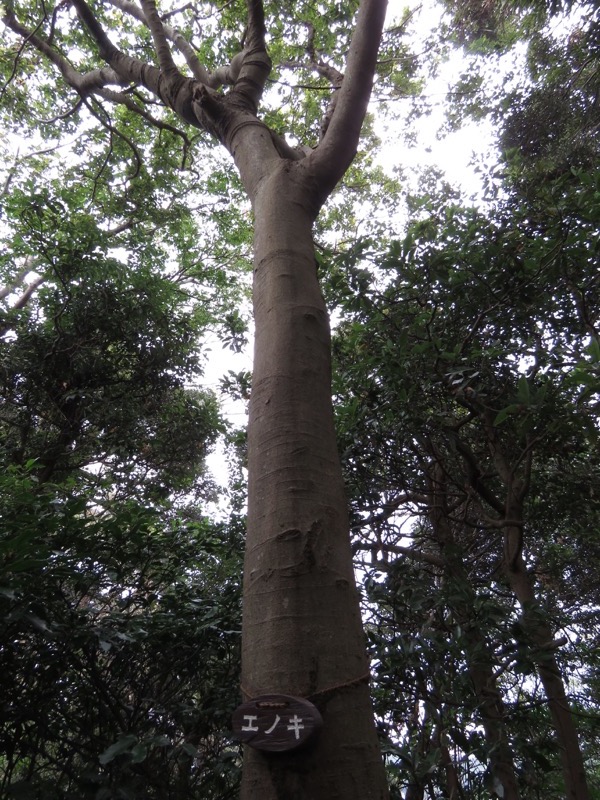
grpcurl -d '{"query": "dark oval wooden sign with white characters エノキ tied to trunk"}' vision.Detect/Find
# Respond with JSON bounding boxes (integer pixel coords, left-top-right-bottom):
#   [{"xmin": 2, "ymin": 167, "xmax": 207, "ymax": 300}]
[{"xmin": 232, "ymin": 694, "xmax": 323, "ymax": 753}]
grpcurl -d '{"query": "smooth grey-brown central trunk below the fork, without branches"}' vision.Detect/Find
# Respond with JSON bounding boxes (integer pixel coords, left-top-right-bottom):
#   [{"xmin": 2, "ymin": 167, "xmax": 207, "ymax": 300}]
[{"xmin": 242, "ymin": 163, "xmax": 387, "ymax": 800}]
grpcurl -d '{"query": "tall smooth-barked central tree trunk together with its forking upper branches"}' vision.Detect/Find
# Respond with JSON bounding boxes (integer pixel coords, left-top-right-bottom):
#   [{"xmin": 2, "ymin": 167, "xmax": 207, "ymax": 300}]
[{"xmin": 3, "ymin": 0, "xmax": 387, "ymax": 800}]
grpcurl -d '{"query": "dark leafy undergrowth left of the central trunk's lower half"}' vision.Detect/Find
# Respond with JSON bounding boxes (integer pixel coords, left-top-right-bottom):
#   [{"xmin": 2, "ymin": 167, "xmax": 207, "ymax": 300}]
[{"xmin": 0, "ymin": 471, "xmax": 241, "ymax": 799}]
